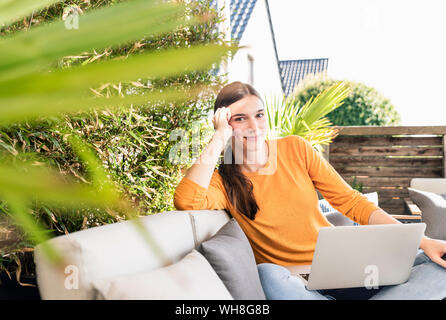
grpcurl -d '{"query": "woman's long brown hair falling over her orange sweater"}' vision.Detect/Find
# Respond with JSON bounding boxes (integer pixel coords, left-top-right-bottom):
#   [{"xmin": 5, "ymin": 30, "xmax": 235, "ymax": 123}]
[{"xmin": 214, "ymin": 81, "xmax": 263, "ymax": 220}]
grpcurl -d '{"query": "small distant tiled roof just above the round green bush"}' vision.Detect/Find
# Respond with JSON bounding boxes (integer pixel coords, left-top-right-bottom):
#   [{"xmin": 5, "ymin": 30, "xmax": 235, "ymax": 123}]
[{"xmin": 279, "ymin": 58, "xmax": 328, "ymax": 96}]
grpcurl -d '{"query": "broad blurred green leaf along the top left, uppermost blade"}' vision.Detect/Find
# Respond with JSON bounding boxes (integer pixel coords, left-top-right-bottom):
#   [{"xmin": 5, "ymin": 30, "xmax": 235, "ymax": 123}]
[{"xmin": 0, "ymin": 0, "xmax": 190, "ymax": 80}]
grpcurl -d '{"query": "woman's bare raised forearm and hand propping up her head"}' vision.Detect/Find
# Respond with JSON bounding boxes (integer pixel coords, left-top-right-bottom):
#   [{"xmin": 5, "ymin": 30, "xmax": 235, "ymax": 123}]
[{"xmin": 185, "ymin": 108, "xmax": 232, "ymax": 189}]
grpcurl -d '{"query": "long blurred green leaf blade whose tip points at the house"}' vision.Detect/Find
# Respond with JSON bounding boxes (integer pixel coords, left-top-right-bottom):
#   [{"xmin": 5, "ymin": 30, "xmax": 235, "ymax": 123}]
[{"xmin": 0, "ymin": 45, "xmax": 229, "ymax": 97}]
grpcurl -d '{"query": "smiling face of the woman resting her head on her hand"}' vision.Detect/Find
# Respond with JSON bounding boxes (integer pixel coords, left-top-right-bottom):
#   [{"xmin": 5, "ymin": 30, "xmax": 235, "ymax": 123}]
[{"xmin": 228, "ymin": 95, "xmax": 268, "ymax": 150}]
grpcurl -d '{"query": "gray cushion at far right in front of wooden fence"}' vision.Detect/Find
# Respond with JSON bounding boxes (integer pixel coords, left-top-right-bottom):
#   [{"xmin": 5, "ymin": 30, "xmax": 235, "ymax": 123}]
[{"xmin": 407, "ymin": 188, "xmax": 446, "ymax": 240}]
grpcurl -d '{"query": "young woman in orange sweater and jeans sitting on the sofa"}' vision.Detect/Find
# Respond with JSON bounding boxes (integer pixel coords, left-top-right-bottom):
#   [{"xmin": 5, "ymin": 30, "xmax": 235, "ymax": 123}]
[{"xmin": 174, "ymin": 82, "xmax": 446, "ymax": 299}]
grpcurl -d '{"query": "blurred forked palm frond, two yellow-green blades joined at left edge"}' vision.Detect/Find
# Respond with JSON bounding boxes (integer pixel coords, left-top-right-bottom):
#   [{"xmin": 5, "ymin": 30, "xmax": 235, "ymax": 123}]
[{"xmin": 0, "ymin": 45, "xmax": 228, "ymax": 125}]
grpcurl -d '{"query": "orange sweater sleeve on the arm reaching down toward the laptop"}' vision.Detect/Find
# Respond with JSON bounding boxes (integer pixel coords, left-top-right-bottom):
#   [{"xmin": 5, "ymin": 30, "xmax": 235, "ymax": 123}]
[{"xmin": 296, "ymin": 136, "xmax": 379, "ymax": 225}]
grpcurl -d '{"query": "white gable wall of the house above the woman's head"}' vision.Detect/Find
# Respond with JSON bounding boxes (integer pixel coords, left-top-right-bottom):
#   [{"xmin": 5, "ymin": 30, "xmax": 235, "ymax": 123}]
[{"xmin": 228, "ymin": 0, "xmax": 283, "ymax": 101}]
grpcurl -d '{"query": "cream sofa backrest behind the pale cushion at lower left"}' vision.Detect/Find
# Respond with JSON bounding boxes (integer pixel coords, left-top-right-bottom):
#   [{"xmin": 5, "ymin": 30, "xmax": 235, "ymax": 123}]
[{"xmin": 34, "ymin": 211, "xmax": 195, "ymax": 300}]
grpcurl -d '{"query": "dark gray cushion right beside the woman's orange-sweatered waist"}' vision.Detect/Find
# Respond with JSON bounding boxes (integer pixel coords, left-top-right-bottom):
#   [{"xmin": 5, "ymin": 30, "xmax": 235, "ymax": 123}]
[{"xmin": 198, "ymin": 218, "xmax": 266, "ymax": 300}]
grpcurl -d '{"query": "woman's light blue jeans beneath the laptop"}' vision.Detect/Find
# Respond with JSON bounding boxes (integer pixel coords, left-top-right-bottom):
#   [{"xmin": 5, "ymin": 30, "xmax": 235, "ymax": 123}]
[{"xmin": 257, "ymin": 250, "xmax": 446, "ymax": 300}]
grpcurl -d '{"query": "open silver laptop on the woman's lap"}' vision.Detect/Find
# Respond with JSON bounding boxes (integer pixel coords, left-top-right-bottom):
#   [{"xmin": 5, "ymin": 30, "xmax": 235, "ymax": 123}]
[{"xmin": 286, "ymin": 223, "xmax": 426, "ymax": 290}]
